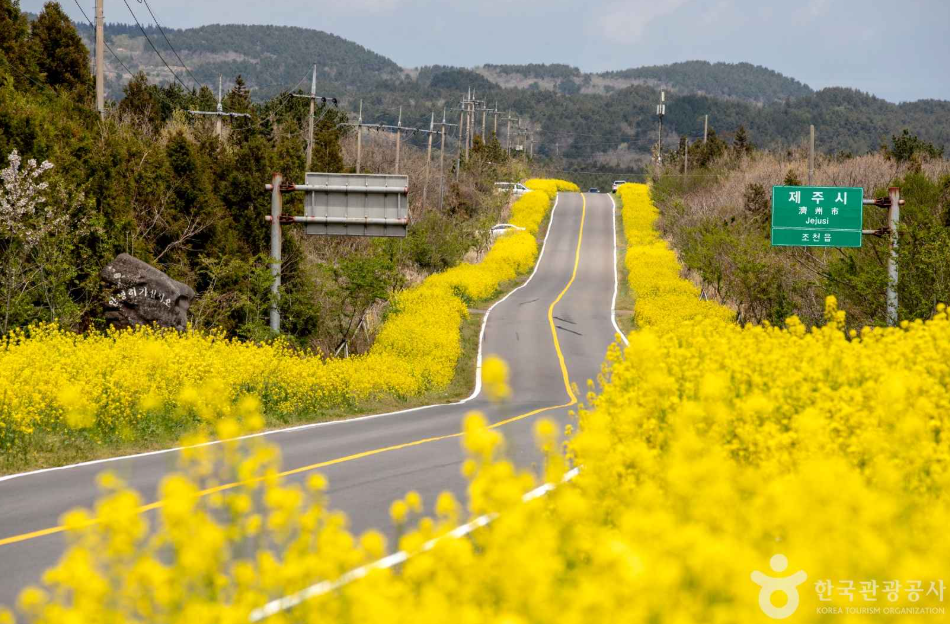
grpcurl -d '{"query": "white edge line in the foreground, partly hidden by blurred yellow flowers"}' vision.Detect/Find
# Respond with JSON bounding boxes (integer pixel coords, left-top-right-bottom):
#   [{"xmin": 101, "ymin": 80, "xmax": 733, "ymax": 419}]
[{"xmin": 250, "ymin": 466, "xmax": 580, "ymax": 622}]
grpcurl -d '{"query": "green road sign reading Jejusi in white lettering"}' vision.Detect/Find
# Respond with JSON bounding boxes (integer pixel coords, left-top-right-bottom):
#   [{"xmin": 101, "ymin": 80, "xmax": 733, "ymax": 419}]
[{"xmin": 772, "ymin": 186, "xmax": 864, "ymax": 247}]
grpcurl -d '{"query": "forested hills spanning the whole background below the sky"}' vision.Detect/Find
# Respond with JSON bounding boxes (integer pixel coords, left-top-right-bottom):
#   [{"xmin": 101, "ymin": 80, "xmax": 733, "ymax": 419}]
[{"xmin": 20, "ymin": 13, "xmax": 950, "ymax": 171}]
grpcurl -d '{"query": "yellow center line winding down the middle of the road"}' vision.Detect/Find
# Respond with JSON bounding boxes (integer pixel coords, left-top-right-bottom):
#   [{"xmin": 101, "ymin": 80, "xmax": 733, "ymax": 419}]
[{"xmin": 0, "ymin": 194, "xmax": 587, "ymax": 546}]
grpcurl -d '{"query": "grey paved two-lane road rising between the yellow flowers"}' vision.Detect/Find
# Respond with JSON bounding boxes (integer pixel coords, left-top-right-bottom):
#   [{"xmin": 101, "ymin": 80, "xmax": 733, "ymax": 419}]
[{"xmin": 0, "ymin": 194, "xmax": 616, "ymax": 605}]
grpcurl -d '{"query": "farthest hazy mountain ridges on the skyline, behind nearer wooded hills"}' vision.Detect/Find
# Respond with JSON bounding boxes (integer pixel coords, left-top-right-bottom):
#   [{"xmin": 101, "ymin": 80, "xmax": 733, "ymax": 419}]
[{"xmin": 77, "ymin": 23, "xmax": 813, "ymax": 103}]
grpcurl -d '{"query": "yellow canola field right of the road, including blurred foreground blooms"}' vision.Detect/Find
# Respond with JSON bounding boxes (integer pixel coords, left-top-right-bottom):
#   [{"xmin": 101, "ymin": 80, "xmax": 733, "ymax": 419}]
[{"xmin": 0, "ymin": 180, "xmax": 950, "ymax": 624}]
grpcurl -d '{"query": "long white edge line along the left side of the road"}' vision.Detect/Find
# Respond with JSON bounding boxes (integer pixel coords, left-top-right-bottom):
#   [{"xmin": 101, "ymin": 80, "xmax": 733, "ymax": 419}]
[{"xmin": 0, "ymin": 191, "xmax": 564, "ymax": 483}]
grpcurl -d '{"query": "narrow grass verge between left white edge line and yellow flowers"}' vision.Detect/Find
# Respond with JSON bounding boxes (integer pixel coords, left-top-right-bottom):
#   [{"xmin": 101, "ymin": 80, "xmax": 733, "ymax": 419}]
[{"xmin": 0, "ymin": 197, "xmax": 551, "ymax": 475}]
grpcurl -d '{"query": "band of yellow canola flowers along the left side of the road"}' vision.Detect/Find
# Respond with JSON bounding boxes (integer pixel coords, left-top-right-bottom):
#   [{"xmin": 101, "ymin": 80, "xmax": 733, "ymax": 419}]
[{"xmin": 0, "ymin": 181, "xmax": 580, "ymax": 453}]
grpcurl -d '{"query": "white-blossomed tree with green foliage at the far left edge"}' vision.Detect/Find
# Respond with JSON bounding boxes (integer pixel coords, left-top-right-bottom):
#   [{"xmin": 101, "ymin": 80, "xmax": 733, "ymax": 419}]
[{"xmin": 0, "ymin": 150, "xmax": 75, "ymax": 334}]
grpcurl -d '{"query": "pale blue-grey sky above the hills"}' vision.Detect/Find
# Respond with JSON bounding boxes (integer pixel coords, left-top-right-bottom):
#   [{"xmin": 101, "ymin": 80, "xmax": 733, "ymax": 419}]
[{"xmin": 21, "ymin": 0, "xmax": 950, "ymax": 102}]
